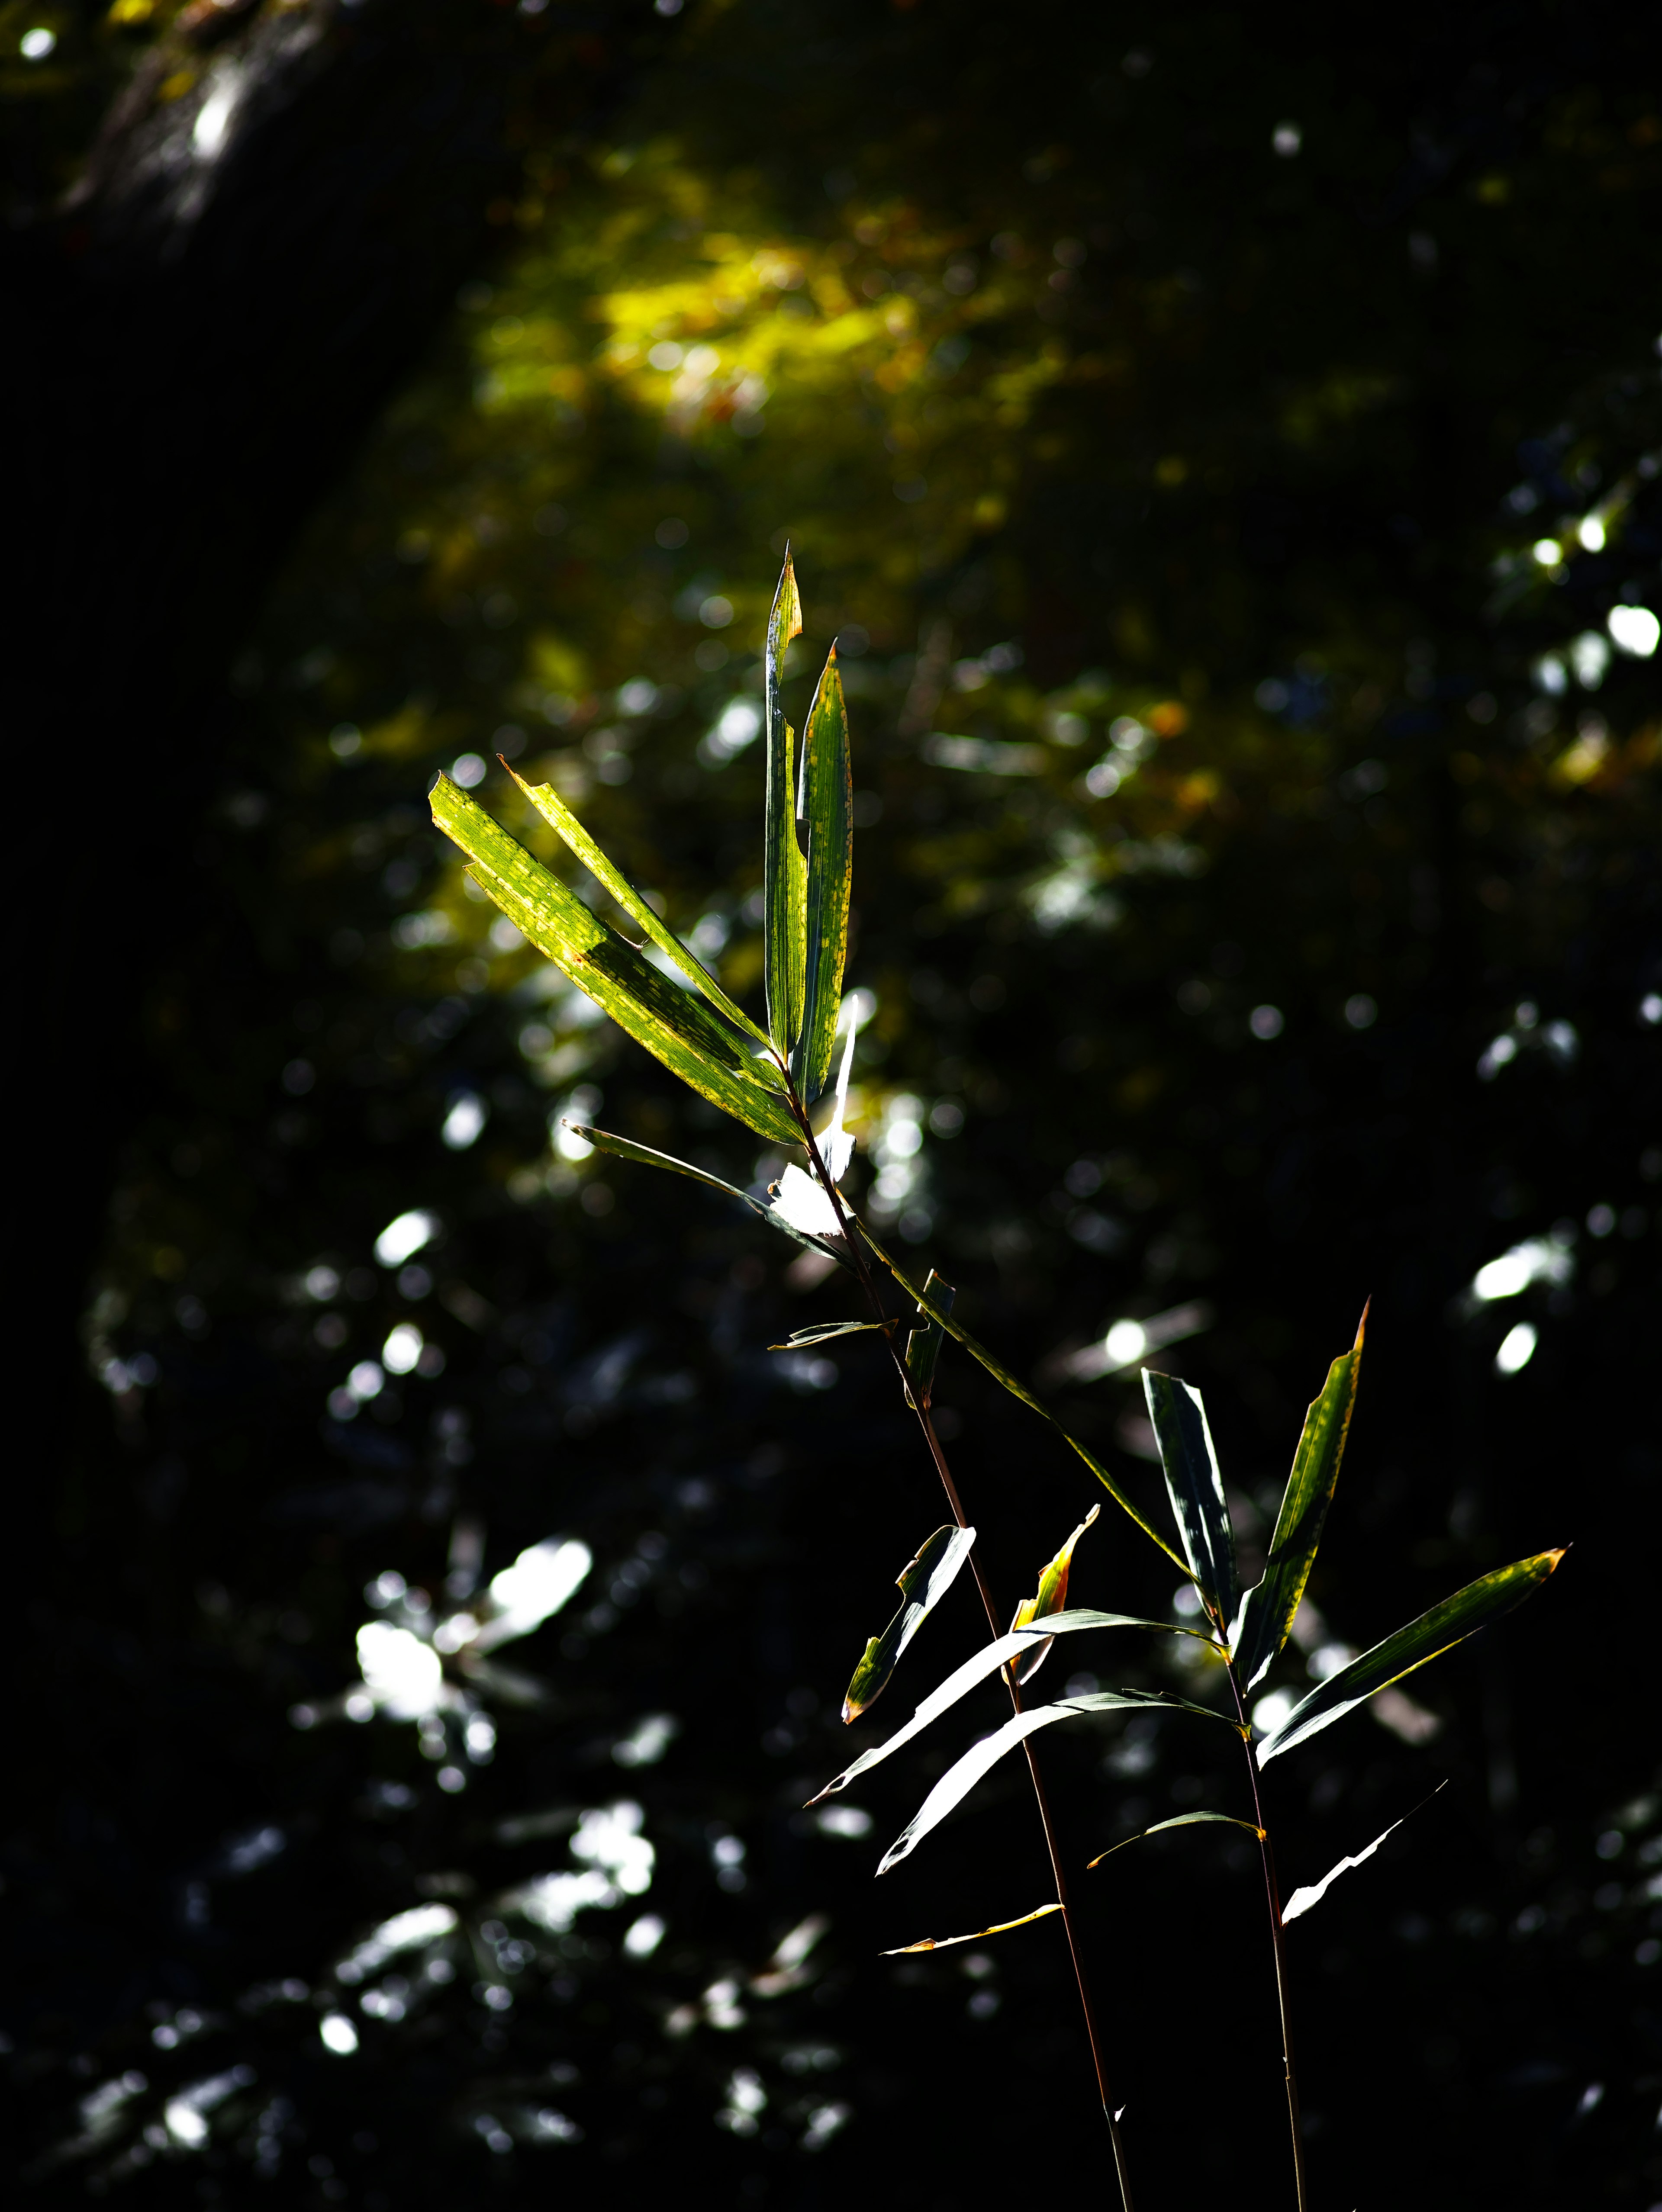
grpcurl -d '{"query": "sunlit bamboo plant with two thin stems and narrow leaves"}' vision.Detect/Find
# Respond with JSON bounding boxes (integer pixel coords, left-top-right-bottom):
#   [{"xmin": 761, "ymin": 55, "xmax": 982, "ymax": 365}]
[{"xmin": 432, "ymin": 555, "xmax": 1562, "ymax": 2212}]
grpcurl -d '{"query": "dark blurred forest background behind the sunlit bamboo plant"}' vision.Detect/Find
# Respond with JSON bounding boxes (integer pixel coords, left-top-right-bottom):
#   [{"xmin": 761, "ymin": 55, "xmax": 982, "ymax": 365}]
[{"xmin": 0, "ymin": 0, "xmax": 1662, "ymax": 2208}]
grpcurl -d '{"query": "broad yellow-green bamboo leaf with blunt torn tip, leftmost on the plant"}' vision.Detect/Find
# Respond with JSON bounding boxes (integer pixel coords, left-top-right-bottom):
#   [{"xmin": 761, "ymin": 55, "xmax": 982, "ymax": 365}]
[{"xmin": 432, "ymin": 776, "xmax": 801, "ymax": 1144}]
